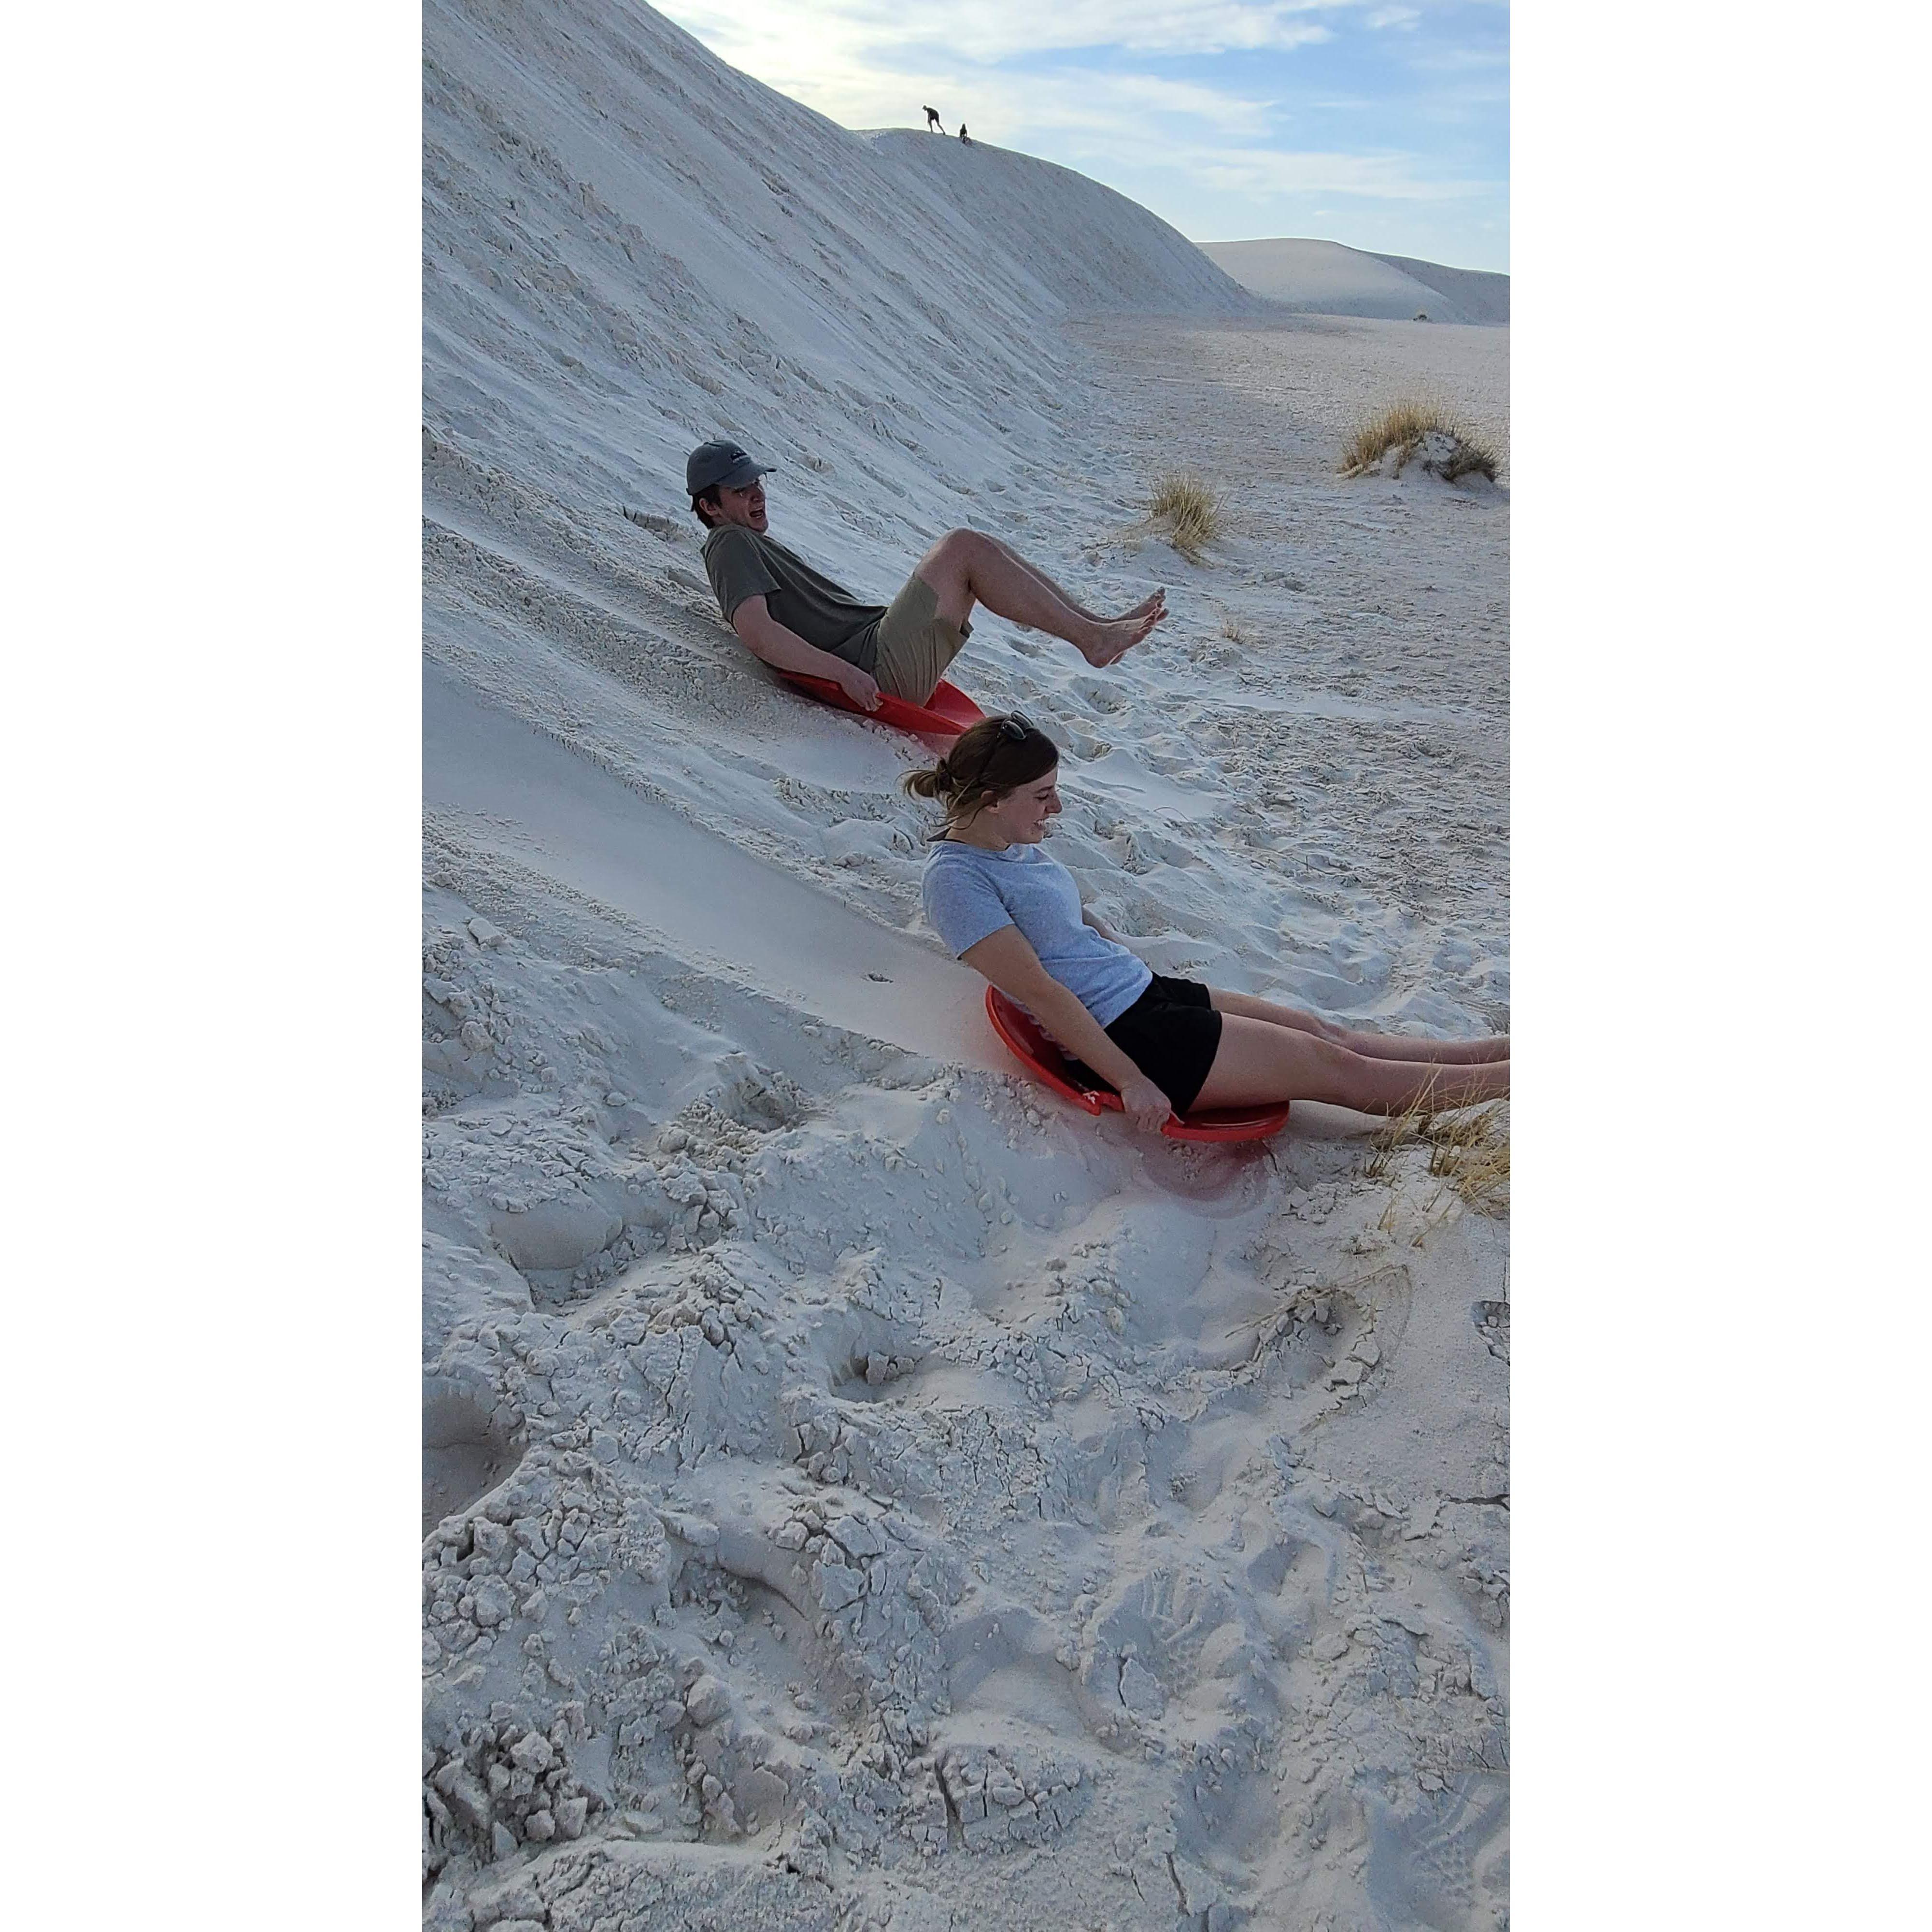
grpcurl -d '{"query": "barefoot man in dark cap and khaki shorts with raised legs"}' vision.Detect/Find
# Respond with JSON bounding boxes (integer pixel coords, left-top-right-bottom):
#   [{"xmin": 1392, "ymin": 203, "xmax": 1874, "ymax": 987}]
[{"xmin": 684, "ymin": 442, "xmax": 1167, "ymax": 711}]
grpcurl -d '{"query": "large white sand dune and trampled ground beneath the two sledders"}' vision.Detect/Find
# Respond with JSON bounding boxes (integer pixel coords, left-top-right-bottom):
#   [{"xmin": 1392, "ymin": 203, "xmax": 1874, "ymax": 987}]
[{"xmin": 423, "ymin": 0, "xmax": 1509, "ymax": 1932}]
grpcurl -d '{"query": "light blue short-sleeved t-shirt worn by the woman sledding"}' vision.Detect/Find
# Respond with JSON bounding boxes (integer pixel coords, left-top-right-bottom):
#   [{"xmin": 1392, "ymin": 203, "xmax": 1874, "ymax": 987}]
[{"xmin": 920, "ymin": 838, "xmax": 1153, "ymax": 1026}]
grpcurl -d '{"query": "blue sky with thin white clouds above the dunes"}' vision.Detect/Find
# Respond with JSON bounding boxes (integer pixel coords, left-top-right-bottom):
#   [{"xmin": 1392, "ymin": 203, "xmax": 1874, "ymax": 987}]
[{"xmin": 657, "ymin": 0, "xmax": 1509, "ymax": 269}]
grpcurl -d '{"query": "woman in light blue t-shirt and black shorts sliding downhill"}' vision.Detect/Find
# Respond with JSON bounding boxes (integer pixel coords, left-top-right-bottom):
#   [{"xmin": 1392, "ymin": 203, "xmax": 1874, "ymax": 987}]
[{"xmin": 906, "ymin": 713, "xmax": 1509, "ymax": 1130}]
